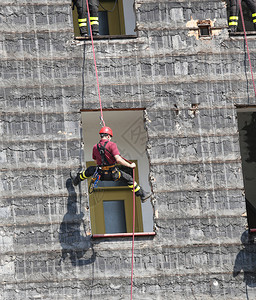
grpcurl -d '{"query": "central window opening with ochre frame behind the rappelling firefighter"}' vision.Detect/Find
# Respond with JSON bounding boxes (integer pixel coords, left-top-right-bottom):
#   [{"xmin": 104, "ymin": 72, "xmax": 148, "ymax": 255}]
[{"xmin": 82, "ymin": 110, "xmax": 153, "ymax": 234}]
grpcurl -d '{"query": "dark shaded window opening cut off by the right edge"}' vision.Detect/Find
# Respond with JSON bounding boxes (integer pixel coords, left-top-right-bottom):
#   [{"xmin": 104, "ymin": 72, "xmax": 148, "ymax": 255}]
[{"xmin": 237, "ymin": 107, "xmax": 256, "ymax": 230}]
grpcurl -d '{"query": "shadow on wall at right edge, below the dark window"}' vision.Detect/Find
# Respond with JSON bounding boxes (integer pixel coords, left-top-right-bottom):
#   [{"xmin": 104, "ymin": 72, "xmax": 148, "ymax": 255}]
[{"xmin": 233, "ymin": 230, "xmax": 256, "ymax": 288}]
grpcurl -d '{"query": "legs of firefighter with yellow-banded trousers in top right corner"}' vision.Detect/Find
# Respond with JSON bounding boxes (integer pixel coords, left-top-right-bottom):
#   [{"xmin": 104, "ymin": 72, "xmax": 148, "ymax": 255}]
[{"xmin": 228, "ymin": 0, "xmax": 256, "ymax": 32}]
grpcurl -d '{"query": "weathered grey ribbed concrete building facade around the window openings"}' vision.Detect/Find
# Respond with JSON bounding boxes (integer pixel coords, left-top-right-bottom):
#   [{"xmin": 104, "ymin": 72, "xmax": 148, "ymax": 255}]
[{"xmin": 0, "ymin": 0, "xmax": 256, "ymax": 300}]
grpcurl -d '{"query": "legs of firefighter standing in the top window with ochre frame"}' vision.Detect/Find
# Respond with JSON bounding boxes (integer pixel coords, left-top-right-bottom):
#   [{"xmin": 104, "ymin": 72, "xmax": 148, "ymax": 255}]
[{"xmin": 72, "ymin": 0, "xmax": 99, "ymax": 37}]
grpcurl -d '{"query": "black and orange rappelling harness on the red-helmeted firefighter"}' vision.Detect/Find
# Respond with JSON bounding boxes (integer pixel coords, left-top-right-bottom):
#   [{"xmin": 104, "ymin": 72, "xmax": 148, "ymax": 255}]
[{"xmin": 89, "ymin": 141, "xmax": 121, "ymax": 194}]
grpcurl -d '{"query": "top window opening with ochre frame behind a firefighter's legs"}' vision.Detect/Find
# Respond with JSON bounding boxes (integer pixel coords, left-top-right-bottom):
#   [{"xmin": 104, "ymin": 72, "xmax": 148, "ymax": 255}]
[{"xmin": 73, "ymin": 0, "xmax": 135, "ymax": 39}]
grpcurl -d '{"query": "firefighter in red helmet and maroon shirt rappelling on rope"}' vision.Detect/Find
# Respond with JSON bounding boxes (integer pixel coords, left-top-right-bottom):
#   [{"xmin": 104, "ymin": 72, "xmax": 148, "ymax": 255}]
[{"xmin": 70, "ymin": 126, "xmax": 151, "ymax": 203}]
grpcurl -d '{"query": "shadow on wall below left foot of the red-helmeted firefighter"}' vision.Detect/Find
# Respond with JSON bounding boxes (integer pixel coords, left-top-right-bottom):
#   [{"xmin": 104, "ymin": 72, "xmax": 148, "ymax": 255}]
[{"xmin": 59, "ymin": 179, "xmax": 96, "ymax": 266}]
